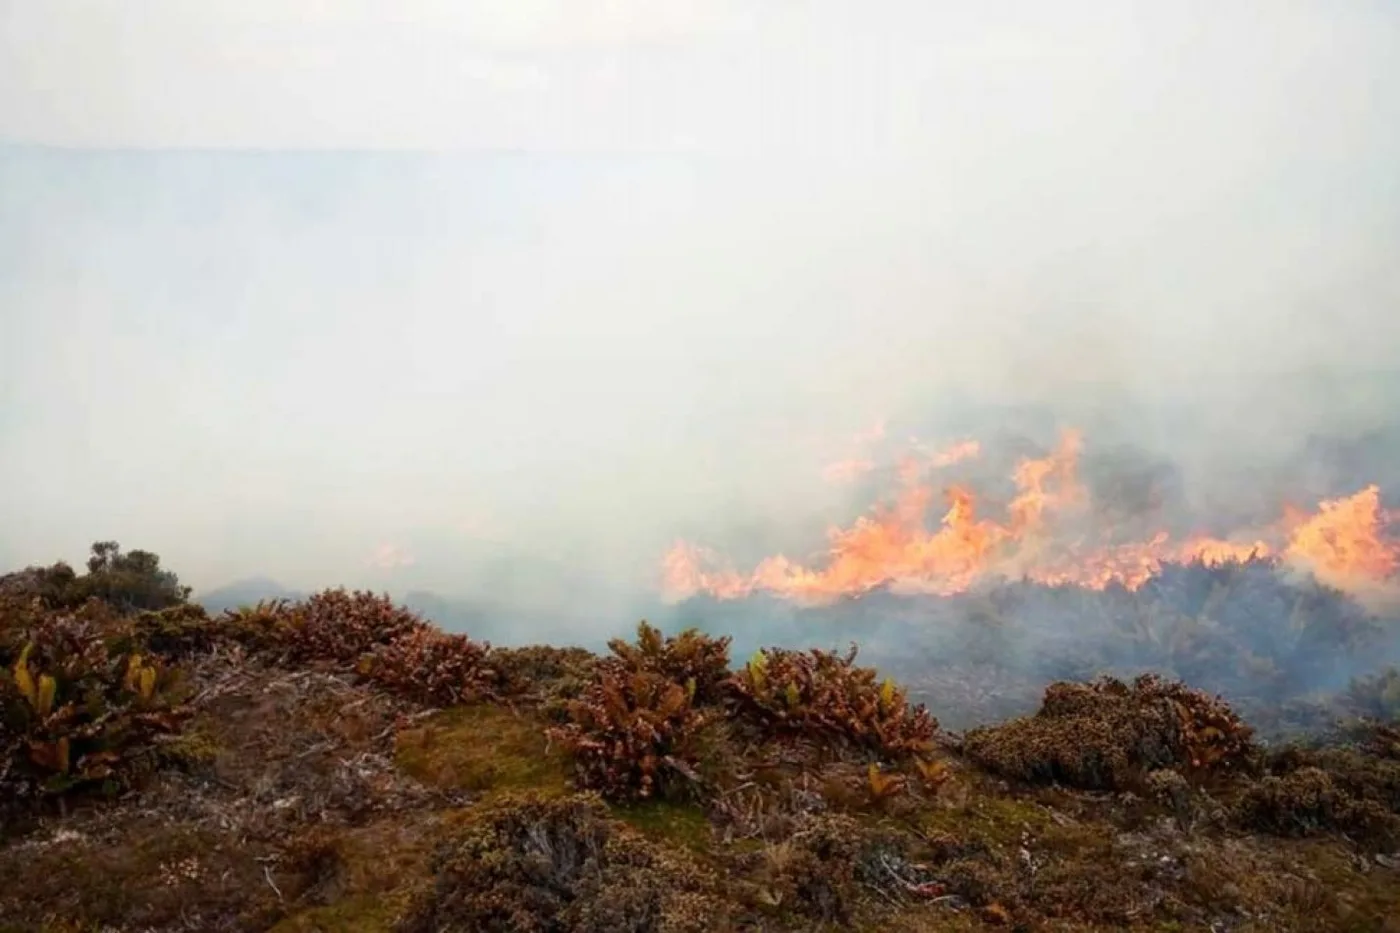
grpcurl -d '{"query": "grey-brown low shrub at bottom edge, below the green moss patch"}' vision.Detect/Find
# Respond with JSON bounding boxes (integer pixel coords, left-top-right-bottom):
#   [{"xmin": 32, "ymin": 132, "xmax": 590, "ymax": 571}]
[{"xmin": 399, "ymin": 796, "xmax": 728, "ymax": 933}]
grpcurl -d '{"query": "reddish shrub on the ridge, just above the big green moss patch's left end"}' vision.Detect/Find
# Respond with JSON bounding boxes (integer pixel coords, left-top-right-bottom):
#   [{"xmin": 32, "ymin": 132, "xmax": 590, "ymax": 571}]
[{"xmin": 361, "ymin": 628, "xmax": 496, "ymax": 706}]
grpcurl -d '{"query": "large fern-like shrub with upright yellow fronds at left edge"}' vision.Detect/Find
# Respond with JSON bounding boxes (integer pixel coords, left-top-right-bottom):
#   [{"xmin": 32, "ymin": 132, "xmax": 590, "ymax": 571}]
[{"xmin": 0, "ymin": 612, "xmax": 189, "ymax": 800}]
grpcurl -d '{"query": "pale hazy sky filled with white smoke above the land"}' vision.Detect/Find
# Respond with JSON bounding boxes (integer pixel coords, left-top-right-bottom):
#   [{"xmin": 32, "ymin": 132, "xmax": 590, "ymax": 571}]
[{"xmin": 0, "ymin": 0, "xmax": 1400, "ymax": 591}]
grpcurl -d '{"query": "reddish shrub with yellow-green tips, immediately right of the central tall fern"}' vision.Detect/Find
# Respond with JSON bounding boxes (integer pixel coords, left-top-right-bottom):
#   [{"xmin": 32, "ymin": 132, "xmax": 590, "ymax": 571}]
[{"xmin": 729, "ymin": 647, "xmax": 938, "ymax": 756}]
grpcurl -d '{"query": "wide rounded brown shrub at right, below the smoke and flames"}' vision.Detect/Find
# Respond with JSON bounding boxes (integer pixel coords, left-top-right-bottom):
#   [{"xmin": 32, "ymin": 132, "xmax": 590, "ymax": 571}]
[{"xmin": 963, "ymin": 674, "xmax": 1253, "ymax": 790}]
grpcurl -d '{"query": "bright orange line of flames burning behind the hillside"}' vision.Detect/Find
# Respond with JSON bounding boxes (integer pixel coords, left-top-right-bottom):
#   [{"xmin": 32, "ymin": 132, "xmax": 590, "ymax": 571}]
[{"xmin": 662, "ymin": 430, "xmax": 1400, "ymax": 604}]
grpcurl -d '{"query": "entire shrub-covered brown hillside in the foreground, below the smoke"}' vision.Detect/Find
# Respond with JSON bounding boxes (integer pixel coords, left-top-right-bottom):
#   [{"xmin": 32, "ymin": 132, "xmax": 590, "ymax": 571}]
[{"xmin": 0, "ymin": 551, "xmax": 1400, "ymax": 933}]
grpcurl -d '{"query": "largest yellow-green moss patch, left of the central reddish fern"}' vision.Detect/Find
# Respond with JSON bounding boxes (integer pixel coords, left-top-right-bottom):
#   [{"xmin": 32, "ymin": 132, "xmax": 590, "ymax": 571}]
[{"xmin": 395, "ymin": 703, "xmax": 570, "ymax": 794}]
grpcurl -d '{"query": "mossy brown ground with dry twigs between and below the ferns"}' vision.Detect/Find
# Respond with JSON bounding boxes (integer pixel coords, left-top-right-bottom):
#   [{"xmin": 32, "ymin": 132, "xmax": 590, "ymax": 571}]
[{"xmin": 0, "ymin": 624, "xmax": 1400, "ymax": 933}]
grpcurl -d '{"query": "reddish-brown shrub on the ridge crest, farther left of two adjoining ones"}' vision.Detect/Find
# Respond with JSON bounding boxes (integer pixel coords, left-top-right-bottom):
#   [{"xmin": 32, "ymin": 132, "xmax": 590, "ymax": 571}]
[{"xmin": 277, "ymin": 588, "xmax": 427, "ymax": 664}]
